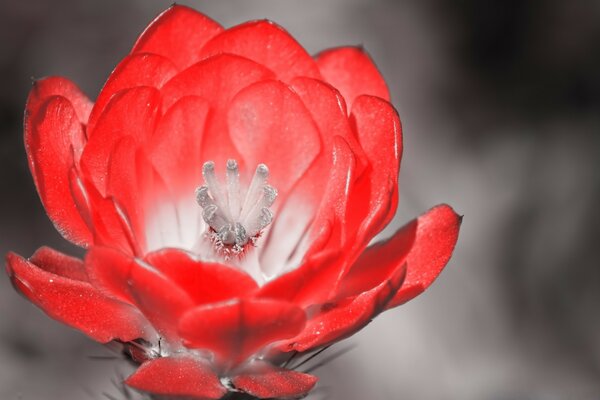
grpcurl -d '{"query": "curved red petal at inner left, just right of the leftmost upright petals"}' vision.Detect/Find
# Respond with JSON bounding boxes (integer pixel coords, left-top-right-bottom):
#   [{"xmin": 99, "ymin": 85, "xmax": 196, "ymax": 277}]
[{"xmin": 81, "ymin": 87, "xmax": 161, "ymax": 194}]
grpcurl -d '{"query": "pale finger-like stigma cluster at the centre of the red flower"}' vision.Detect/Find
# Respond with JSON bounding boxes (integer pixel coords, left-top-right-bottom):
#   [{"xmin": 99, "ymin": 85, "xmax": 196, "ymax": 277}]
[{"xmin": 196, "ymin": 160, "xmax": 277, "ymax": 258}]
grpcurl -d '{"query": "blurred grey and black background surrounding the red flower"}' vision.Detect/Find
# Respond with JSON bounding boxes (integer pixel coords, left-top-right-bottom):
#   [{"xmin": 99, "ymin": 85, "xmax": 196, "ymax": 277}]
[{"xmin": 0, "ymin": 0, "xmax": 600, "ymax": 400}]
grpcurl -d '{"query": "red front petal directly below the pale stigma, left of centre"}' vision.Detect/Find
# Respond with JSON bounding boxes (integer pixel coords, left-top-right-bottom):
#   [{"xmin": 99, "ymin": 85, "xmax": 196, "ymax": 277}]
[{"xmin": 145, "ymin": 249, "xmax": 258, "ymax": 305}]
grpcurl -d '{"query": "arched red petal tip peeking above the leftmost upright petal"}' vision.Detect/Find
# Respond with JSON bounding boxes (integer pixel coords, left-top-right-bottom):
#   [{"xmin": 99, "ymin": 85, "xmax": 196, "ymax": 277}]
[{"xmin": 26, "ymin": 76, "xmax": 94, "ymax": 125}]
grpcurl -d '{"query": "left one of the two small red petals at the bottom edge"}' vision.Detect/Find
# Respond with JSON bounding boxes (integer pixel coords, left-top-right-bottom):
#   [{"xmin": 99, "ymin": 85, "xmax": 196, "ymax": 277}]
[{"xmin": 125, "ymin": 357, "xmax": 227, "ymax": 400}]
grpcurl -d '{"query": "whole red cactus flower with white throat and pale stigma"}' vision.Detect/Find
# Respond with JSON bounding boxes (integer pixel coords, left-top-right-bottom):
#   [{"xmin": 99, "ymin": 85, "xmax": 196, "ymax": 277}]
[{"xmin": 7, "ymin": 5, "xmax": 460, "ymax": 399}]
